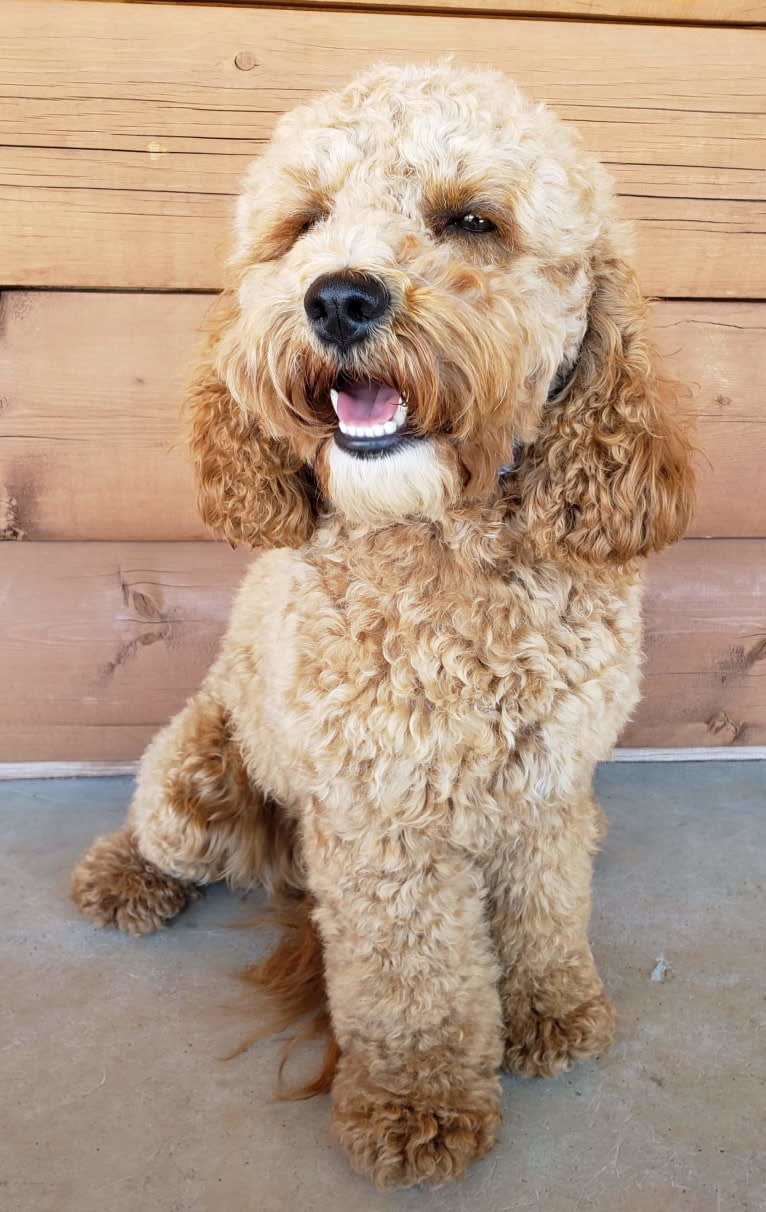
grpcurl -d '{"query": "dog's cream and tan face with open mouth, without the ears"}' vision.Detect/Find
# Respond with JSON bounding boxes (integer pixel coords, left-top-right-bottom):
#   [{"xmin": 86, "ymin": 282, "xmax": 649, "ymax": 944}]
[{"xmin": 219, "ymin": 67, "xmax": 608, "ymax": 520}]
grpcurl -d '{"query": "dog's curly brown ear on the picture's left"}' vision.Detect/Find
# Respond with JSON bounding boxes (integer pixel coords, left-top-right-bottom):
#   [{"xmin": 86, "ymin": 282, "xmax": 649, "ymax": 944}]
[{"xmin": 184, "ymin": 292, "xmax": 315, "ymax": 547}]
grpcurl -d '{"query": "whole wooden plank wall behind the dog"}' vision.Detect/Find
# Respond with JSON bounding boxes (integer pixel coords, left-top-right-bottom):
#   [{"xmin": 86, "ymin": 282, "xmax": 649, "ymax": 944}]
[{"xmin": 0, "ymin": 0, "xmax": 766, "ymax": 761}]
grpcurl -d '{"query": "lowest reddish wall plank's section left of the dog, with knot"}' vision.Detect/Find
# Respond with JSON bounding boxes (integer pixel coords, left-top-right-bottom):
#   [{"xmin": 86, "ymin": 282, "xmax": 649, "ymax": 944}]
[{"xmin": 0, "ymin": 543, "xmax": 248, "ymax": 761}]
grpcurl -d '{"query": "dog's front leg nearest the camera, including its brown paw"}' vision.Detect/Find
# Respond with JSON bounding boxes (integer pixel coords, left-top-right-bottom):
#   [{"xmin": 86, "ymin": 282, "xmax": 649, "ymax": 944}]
[{"xmin": 307, "ymin": 829, "xmax": 503, "ymax": 1187}]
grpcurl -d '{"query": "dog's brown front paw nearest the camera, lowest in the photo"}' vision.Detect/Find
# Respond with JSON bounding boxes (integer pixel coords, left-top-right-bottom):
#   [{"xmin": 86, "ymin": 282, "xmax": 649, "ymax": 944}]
[{"xmin": 333, "ymin": 1085, "xmax": 501, "ymax": 1188}]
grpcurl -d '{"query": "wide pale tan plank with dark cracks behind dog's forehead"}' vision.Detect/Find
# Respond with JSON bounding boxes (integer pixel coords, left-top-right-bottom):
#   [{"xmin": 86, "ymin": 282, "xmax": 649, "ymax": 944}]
[{"xmin": 0, "ymin": 0, "xmax": 766, "ymax": 297}]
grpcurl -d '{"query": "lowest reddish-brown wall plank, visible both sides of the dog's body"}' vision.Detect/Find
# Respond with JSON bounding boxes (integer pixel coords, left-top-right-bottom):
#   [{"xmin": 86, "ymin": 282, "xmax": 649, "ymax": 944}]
[{"xmin": 0, "ymin": 541, "xmax": 766, "ymax": 762}]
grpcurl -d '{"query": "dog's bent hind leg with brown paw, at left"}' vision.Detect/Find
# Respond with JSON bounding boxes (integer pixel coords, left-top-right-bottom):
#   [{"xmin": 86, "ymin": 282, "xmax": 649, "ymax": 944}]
[{"xmin": 72, "ymin": 690, "xmax": 297, "ymax": 934}]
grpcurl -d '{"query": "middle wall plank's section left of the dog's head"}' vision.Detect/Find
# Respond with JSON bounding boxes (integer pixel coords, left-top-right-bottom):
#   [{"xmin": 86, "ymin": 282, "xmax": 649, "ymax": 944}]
[{"xmin": 0, "ymin": 292, "xmax": 210, "ymax": 539}]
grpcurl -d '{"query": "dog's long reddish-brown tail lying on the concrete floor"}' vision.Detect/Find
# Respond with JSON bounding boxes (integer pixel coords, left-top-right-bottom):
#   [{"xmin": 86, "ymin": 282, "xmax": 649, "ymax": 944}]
[{"xmin": 231, "ymin": 892, "xmax": 341, "ymax": 1099}]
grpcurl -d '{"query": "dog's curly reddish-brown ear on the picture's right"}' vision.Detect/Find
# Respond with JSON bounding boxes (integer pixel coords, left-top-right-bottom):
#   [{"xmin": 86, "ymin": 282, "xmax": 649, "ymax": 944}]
[{"xmin": 518, "ymin": 255, "xmax": 693, "ymax": 562}]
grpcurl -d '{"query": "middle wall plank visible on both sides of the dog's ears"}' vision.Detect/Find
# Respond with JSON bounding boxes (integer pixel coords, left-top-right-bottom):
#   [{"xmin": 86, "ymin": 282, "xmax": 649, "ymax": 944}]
[{"xmin": 0, "ymin": 291, "xmax": 766, "ymax": 541}]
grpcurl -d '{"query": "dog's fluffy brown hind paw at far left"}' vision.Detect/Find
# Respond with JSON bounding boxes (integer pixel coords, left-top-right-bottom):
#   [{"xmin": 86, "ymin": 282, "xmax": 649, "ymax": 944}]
[{"xmin": 72, "ymin": 830, "xmax": 199, "ymax": 936}]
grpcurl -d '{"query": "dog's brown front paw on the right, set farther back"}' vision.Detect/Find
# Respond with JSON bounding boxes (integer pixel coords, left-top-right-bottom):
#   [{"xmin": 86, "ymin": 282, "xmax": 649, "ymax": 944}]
[{"xmin": 503, "ymin": 993, "xmax": 617, "ymax": 1077}]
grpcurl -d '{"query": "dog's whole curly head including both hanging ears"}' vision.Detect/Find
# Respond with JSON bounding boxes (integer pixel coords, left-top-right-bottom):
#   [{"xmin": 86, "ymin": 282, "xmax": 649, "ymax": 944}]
[{"xmin": 189, "ymin": 65, "xmax": 690, "ymax": 559}]
